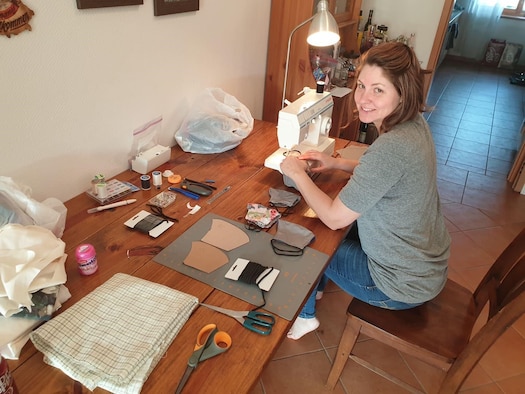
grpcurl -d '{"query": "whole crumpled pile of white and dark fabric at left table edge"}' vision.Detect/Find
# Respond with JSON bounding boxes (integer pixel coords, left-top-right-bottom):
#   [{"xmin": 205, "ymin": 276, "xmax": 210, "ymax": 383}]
[{"xmin": 0, "ymin": 223, "xmax": 71, "ymax": 359}]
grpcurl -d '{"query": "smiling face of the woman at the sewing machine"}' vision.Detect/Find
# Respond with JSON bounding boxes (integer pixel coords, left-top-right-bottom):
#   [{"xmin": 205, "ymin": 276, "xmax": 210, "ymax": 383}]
[{"xmin": 354, "ymin": 65, "xmax": 401, "ymax": 130}]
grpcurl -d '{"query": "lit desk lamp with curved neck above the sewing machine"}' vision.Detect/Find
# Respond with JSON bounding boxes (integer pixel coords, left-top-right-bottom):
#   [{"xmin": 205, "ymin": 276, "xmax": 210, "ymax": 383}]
[{"xmin": 281, "ymin": 0, "xmax": 340, "ymax": 108}]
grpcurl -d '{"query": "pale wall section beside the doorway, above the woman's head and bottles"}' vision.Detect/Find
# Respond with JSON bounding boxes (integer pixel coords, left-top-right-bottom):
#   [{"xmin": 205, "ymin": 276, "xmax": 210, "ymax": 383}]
[{"xmin": 361, "ymin": 0, "xmax": 445, "ymax": 68}]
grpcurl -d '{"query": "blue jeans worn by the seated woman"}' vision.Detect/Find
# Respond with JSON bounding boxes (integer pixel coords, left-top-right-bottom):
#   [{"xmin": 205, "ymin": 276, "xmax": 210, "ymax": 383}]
[{"xmin": 299, "ymin": 238, "xmax": 421, "ymax": 319}]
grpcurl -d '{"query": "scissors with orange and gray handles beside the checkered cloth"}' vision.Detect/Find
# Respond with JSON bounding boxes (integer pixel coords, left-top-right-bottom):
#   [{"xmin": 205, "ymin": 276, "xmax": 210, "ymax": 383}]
[{"xmin": 175, "ymin": 323, "xmax": 232, "ymax": 394}]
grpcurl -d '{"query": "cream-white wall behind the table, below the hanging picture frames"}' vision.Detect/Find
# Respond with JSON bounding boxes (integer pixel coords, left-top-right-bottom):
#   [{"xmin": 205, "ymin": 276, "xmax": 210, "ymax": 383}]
[{"xmin": 0, "ymin": 0, "xmax": 270, "ymax": 201}]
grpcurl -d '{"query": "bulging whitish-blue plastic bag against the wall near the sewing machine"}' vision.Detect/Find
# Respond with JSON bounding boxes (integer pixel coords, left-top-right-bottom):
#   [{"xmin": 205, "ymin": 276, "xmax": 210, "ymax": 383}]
[{"xmin": 175, "ymin": 88, "xmax": 253, "ymax": 153}]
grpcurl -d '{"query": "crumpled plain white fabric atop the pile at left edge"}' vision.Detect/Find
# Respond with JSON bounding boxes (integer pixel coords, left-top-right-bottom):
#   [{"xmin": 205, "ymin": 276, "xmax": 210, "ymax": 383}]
[{"xmin": 0, "ymin": 223, "xmax": 67, "ymax": 317}]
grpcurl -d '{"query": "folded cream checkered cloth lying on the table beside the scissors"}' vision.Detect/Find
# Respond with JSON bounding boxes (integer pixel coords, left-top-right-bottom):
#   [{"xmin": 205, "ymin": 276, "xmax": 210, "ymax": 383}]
[{"xmin": 31, "ymin": 274, "xmax": 199, "ymax": 393}]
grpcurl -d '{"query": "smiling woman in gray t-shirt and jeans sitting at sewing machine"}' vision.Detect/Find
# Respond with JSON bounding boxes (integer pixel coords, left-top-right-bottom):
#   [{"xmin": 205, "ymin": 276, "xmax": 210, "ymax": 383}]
[{"xmin": 281, "ymin": 42, "xmax": 450, "ymax": 339}]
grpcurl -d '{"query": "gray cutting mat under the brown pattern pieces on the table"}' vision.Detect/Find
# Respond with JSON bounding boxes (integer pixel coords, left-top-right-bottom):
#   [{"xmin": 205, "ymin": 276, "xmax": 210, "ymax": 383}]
[{"xmin": 153, "ymin": 213, "xmax": 328, "ymax": 320}]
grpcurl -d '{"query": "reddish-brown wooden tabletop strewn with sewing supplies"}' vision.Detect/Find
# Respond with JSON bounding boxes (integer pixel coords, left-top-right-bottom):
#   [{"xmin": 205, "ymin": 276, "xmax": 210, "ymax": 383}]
[{"xmin": 9, "ymin": 121, "xmax": 348, "ymax": 394}]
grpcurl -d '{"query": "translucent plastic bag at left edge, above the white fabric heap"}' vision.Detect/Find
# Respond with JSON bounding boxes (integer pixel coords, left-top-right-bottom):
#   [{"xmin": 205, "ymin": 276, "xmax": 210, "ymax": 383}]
[{"xmin": 0, "ymin": 176, "xmax": 67, "ymax": 238}]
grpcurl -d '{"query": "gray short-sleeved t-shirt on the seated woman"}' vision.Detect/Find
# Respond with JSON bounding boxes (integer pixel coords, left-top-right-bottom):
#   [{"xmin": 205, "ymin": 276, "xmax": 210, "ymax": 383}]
[{"xmin": 339, "ymin": 115, "xmax": 450, "ymax": 303}]
